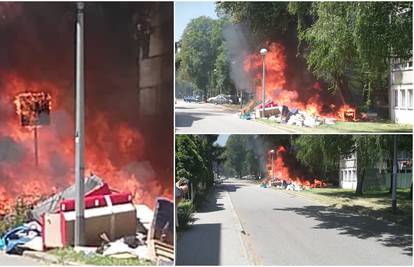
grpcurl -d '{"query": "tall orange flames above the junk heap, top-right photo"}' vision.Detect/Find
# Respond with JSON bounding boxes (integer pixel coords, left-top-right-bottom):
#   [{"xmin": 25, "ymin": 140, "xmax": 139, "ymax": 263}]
[{"xmin": 243, "ymin": 42, "xmax": 355, "ymax": 121}]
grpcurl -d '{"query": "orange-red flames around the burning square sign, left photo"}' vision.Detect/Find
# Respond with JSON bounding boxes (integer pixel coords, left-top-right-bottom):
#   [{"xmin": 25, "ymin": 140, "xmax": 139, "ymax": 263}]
[{"xmin": 0, "ymin": 72, "xmax": 172, "ymax": 214}]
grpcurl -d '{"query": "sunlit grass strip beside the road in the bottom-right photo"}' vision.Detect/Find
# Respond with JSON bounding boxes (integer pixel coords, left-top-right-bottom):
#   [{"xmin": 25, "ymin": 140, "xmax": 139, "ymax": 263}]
[{"xmin": 289, "ymin": 188, "xmax": 413, "ymax": 226}]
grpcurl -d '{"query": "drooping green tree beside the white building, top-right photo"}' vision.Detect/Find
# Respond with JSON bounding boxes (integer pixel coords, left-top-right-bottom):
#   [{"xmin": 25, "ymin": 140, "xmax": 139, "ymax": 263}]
[{"xmin": 290, "ymin": 2, "xmax": 412, "ymax": 108}]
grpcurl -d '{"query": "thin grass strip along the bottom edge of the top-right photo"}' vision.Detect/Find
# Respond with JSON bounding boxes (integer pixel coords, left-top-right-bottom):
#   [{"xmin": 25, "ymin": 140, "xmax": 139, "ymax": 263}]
[{"xmin": 256, "ymin": 119, "xmax": 413, "ymax": 133}]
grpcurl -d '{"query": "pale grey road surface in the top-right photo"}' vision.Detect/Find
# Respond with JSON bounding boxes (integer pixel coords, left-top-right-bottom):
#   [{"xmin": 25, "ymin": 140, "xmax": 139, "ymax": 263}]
[{"xmin": 175, "ymin": 99, "xmax": 289, "ymax": 134}]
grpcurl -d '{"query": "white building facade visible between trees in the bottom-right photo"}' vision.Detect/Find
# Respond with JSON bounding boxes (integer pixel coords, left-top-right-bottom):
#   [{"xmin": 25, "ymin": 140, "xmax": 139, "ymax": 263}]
[{"xmin": 339, "ymin": 152, "xmax": 357, "ymax": 189}]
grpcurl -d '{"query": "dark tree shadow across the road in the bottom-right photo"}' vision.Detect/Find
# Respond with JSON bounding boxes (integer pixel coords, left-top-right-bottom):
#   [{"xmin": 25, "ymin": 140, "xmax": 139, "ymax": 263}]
[{"xmin": 273, "ymin": 206, "xmax": 413, "ymax": 256}]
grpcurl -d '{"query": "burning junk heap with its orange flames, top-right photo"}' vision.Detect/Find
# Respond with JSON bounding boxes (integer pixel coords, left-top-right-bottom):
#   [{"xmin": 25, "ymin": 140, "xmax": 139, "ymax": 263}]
[{"xmin": 240, "ymin": 43, "xmax": 357, "ymax": 127}]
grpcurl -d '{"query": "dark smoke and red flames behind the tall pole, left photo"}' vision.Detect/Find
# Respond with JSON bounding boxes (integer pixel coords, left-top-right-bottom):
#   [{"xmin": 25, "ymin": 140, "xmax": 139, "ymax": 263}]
[{"xmin": 0, "ymin": 2, "xmax": 173, "ymax": 209}]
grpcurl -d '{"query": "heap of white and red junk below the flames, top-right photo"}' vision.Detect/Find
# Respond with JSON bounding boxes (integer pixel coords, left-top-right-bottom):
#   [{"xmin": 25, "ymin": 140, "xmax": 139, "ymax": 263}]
[{"xmin": 239, "ymin": 100, "xmax": 356, "ymax": 128}]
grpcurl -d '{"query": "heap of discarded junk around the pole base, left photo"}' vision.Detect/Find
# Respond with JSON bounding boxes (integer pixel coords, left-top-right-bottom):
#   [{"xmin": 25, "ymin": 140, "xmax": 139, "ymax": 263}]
[{"xmin": 0, "ymin": 175, "xmax": 174, "ymax": 265}]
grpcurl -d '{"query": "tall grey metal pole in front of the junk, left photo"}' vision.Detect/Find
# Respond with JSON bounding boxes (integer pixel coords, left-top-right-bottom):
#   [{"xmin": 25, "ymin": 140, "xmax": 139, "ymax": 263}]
[{"xmin": 75, "ymin": 2, "xmax": 85, "ymax": 249}]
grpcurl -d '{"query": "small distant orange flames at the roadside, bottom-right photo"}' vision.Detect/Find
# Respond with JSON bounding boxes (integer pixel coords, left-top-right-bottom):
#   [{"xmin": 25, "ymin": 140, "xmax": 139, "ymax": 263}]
[{"xmin": 267, "ymin": 146, "xmax": 326, "ymax": 188}]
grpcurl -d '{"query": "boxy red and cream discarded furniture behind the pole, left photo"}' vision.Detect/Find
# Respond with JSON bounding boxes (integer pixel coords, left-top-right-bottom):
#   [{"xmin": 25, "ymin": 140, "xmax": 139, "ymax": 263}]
[{"xmin": 42, "ymin": 193, "xmax": 137, "ymax": 248}]
